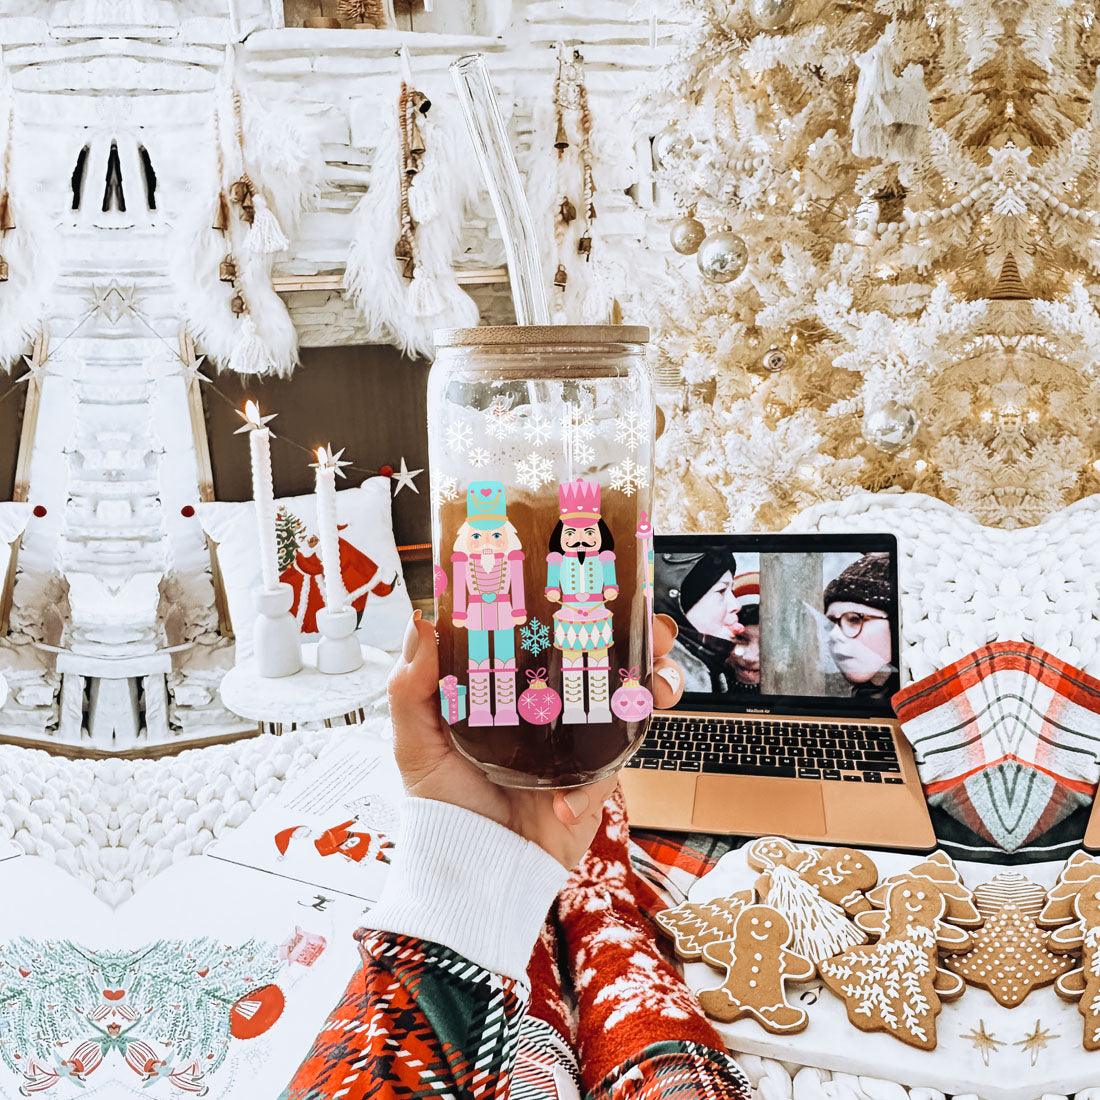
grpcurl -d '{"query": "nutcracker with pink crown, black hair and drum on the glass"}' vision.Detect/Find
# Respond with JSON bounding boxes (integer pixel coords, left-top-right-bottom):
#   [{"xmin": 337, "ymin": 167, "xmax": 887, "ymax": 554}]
[{"xmin": 546, "ymin": 477, "xmax": 618, "ymax": 723}]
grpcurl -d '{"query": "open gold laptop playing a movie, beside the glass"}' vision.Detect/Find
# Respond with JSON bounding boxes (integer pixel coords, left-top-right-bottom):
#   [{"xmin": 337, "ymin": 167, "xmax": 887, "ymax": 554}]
[{"xmin": 623, "ymin": 534, "xmax": 936, "ymax": 850}]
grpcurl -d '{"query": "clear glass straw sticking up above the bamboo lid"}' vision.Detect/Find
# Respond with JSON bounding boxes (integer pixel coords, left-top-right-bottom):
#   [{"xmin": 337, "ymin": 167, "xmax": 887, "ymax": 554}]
[{"xmin": 451, "ymin": 54, "xmax": 550, "ymax": 325}]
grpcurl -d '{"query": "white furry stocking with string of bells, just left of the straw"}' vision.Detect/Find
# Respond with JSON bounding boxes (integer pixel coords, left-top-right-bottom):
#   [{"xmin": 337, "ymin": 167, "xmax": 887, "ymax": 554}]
[{"xmin": 344, "ymin": 66, "xmax": 477, "ymax": 356}]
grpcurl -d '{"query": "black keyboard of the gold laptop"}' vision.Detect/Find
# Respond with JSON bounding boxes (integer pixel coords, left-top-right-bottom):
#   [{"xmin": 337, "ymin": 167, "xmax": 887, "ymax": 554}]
[{"xmin": 627, "ymin": 714, "xmax": 904, "ymax": 783}]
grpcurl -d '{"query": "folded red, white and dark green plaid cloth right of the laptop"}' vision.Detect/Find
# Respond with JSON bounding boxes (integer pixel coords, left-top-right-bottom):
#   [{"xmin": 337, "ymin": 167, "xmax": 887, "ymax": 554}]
[{"xmin": 893, "ymin": 641, "xmax": 1100, "ymax": 853}]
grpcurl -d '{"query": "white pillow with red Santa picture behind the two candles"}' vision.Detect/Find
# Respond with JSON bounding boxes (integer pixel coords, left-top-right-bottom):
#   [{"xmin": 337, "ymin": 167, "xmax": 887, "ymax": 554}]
[{"xmin": 198, "ymin": 477, "xmax": 413, "ymax": 661}]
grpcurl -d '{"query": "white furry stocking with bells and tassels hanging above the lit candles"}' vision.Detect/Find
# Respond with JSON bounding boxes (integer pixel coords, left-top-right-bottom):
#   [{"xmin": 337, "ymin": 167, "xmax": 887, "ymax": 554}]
[{"xmin": 173, "ymin": 47, "xmax": 325, "ymax": 375}]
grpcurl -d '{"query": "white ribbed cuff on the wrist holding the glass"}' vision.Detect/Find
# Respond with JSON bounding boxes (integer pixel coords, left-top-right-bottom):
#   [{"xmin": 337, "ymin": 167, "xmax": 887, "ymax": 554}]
[{"xmin": 367, "ymin": 799, "xmax": 569, "ymax": 979}]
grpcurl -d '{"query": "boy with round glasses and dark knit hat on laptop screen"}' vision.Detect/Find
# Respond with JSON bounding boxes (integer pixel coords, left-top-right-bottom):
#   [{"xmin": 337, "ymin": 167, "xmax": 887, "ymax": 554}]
[{"xmin": 823, "ymin": 553, "xmax": 900, "ymax": 699}]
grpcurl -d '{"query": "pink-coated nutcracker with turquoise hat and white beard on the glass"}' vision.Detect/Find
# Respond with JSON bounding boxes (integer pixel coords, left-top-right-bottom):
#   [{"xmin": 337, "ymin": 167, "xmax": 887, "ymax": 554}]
[{"xmin": 451, "ymin": 481, "xmax": 527, "ymax": 726}]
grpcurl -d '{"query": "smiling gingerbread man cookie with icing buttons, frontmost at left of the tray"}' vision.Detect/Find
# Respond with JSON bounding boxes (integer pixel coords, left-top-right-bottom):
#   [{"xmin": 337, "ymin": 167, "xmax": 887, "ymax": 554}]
[{"xmin": 699, "ymin": 905, "xmax": 814, "ymax": 1035}]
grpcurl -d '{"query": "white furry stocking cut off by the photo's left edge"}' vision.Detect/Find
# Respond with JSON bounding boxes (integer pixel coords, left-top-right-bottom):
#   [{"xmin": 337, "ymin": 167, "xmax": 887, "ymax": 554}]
[{"xmin": 0, "ymin": 58, "xmax": 58, "ymax": 371}]
